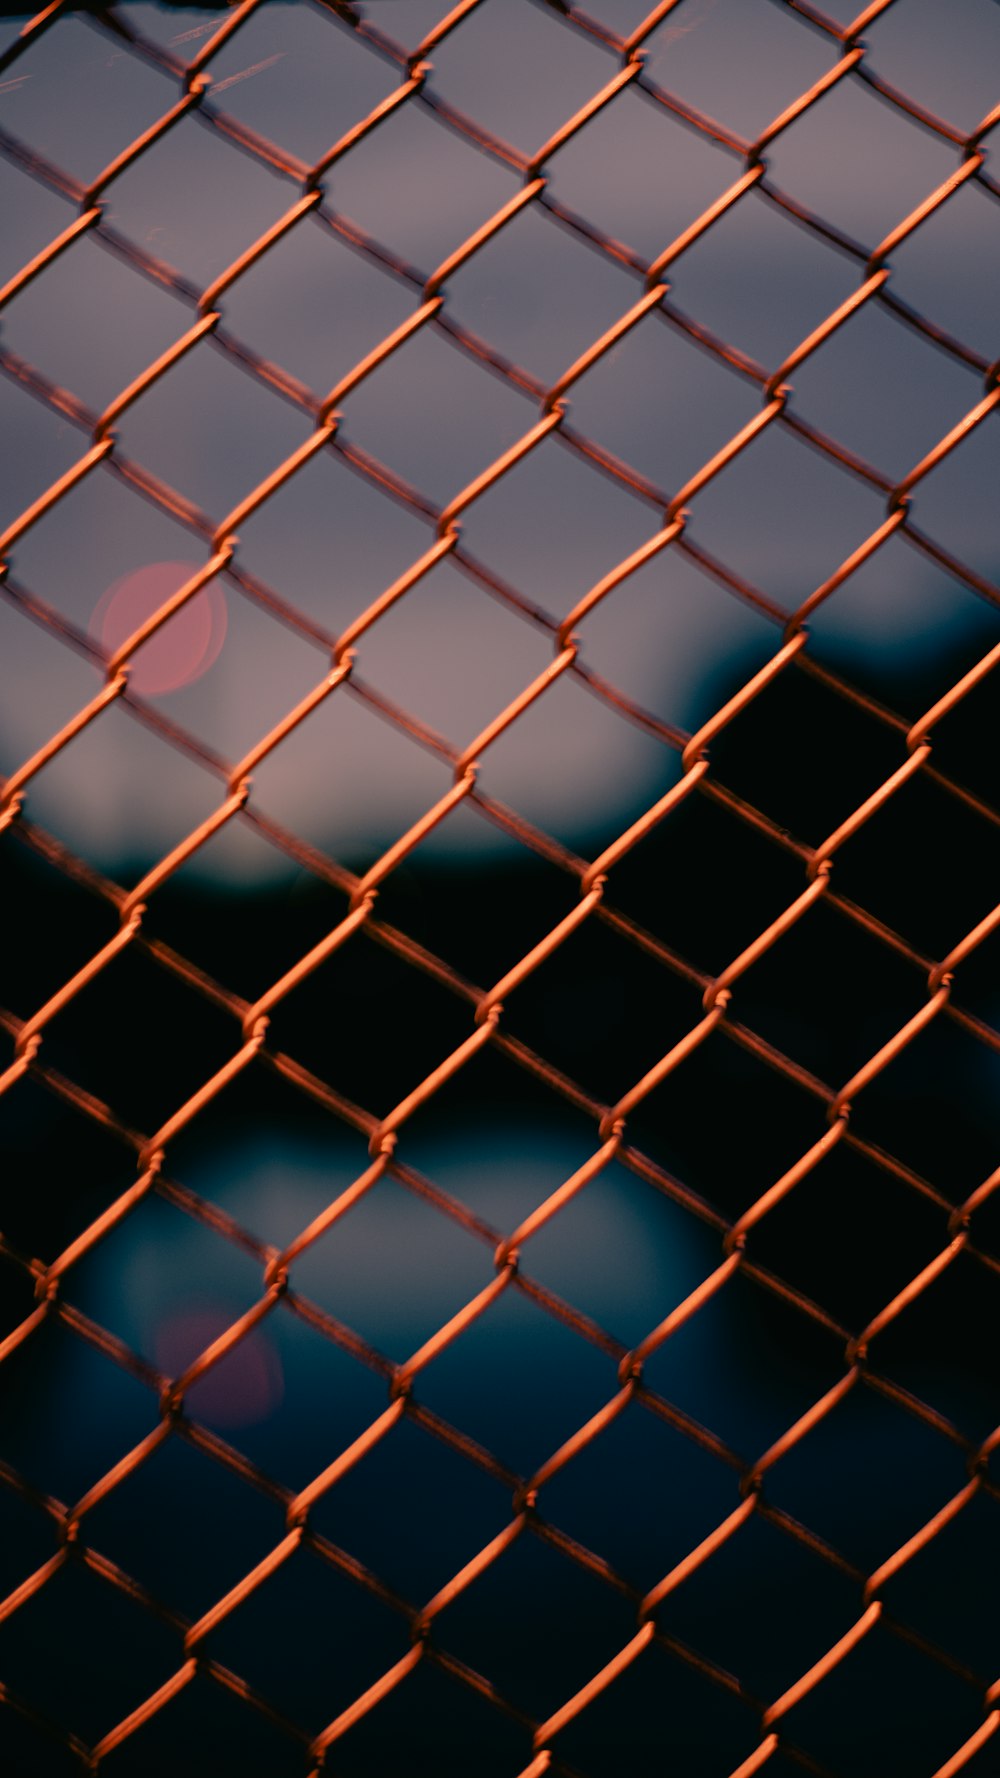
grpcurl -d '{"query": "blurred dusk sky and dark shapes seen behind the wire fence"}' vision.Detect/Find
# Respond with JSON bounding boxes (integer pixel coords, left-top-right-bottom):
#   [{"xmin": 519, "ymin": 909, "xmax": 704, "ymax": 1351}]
[{"xmin": 0, "ymin": 0, "xmax": 1000, "ymax": 1778}]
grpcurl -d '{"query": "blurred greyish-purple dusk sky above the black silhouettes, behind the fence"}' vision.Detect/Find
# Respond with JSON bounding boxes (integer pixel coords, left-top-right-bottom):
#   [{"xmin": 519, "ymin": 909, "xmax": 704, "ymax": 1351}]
[{"xmin": 0, "ymin": 0, "xmax": 1000, "ymax": 878}]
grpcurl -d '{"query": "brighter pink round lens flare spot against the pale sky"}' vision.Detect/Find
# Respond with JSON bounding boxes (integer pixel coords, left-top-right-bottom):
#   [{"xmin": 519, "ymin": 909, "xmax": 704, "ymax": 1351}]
[{"xmin": 91, "ymin": 562, "xmax": 226, "ymax": 697}]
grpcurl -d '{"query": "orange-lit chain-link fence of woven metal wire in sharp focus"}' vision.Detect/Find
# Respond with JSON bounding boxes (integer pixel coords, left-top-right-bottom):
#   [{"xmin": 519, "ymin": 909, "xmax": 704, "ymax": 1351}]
[{"xmin": 0, "ymin": 0, "xmax": 1000, "ymax": 1778}]
